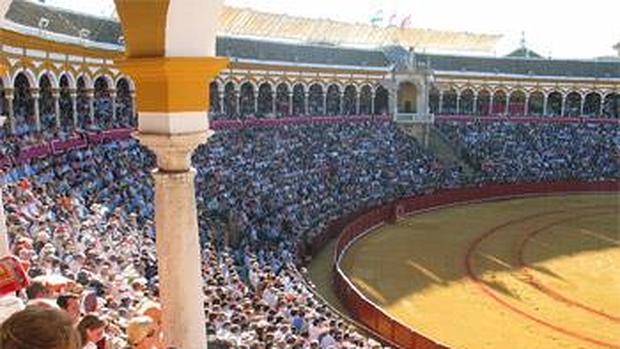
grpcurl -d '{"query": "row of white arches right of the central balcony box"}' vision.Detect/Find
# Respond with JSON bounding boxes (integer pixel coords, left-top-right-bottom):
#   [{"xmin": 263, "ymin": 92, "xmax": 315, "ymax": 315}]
[{"xmin": 429, "ymin": 86, "xmax": 620, "ymax": 118}]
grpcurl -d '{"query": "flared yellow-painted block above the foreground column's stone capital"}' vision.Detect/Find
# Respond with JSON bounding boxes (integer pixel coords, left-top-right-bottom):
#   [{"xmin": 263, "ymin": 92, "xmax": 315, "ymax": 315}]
[{"xmin": 118, "ymin": 57, "xmax": 229, "ymax": 113}]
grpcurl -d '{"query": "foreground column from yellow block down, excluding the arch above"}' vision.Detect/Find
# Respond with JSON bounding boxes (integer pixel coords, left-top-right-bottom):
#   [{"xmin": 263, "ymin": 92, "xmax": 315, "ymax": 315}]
[{"xmin": 120, "ymin": 57, "xmax": 228, "ymax": 349}]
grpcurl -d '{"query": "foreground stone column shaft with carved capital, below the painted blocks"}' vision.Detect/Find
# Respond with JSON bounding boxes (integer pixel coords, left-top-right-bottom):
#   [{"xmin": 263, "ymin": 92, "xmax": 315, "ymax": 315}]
[{"xmin": 138, "ymin": 132, "xmax": 207, "ymax": 349}]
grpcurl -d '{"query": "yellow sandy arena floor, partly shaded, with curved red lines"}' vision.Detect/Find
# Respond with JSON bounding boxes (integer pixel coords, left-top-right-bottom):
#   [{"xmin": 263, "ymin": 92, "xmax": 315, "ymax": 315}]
[{"xmin": 342, "ymin": 194, "xmax": 620, "ymax": 349}]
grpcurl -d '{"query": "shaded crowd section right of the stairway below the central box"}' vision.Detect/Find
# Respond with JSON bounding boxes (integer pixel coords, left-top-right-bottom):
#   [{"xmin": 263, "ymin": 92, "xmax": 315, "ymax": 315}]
[{"xmin": 438, "ymin": 121, "xmax": 620, "ymax": 182}]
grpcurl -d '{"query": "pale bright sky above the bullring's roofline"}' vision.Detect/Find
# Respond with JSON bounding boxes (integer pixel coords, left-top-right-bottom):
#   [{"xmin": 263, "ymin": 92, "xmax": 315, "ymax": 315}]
[{"xmin": 46, "ymin": 0, "xmax": 620, "ymax": 58}]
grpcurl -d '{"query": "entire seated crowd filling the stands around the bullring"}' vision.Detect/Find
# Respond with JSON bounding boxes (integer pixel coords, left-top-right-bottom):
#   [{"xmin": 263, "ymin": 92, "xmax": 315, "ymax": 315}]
[{"xmin": 0, "ymin": 113, "xmax": 618, "ymax": 349}]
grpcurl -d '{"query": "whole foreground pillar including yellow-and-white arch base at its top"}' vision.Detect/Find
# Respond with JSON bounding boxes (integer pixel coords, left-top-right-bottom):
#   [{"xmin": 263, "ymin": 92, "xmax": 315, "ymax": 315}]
[{"xmin": 115, "ymin": 0, "xmax": 228, "ymax": 349}]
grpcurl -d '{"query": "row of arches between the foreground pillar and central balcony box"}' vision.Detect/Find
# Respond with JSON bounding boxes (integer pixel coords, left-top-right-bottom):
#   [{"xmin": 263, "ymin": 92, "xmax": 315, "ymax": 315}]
[{"xmin": 209, "ymin": 80, "xmax": 389, "ymax": 119}]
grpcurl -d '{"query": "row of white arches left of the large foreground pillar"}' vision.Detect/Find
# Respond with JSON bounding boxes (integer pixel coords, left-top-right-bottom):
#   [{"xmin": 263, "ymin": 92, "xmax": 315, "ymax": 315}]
[{"xmin": 0, "ymin": 69, "xmax": 137, "ymax": 135}]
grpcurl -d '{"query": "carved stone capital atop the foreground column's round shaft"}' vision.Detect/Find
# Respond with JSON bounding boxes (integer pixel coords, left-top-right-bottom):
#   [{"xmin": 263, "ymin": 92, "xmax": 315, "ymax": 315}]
[{"xmin": 134, "ymin": 131, "xmax": 213, "ymax": 172}]
